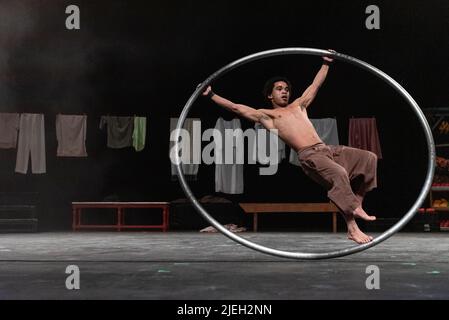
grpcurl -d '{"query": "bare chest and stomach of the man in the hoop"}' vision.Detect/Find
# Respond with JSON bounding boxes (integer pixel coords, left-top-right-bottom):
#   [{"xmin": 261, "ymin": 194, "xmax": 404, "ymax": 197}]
[{"xmin": 259, "ymin": 104, "xmax": 322, "ymax": 151}]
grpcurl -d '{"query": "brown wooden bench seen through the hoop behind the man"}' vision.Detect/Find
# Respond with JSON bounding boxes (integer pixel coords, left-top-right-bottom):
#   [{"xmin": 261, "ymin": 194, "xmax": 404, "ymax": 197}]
[{"xmin": 239, "ymin": 202, "xmax": 338, "ymax": 232}]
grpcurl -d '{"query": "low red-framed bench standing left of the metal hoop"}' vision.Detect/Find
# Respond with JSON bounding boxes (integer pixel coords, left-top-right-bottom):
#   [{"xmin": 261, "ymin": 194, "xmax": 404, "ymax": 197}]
[{"xmin": 72, "ymin": 202, "xmax": 169, "ymax": 232}]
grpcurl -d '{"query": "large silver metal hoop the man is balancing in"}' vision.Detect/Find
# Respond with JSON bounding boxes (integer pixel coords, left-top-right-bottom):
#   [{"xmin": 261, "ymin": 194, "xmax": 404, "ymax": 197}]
[{"xmin": 175, "ymin": 48, "xmax": 435, "ymax": 260}]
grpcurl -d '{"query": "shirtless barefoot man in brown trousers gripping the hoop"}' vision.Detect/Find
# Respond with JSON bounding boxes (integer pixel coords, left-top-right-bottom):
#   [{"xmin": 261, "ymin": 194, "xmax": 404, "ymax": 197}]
[{"xmin": 203, "ymin": 51, "xmax": 377, "ymax": 244}]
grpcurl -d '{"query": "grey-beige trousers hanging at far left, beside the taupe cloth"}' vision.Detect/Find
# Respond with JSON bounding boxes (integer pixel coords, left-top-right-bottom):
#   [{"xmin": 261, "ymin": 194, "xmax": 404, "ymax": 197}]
[{"xmin": 16, "ymin": 113, "xmax": 46, "ymax": 174}]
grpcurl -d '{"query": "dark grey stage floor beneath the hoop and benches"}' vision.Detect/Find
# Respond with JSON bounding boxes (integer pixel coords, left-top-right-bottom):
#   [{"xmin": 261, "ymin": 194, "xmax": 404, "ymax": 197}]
[{"xmin": 0, "ymin": 231, "xmax": 449, "ymax": 300}]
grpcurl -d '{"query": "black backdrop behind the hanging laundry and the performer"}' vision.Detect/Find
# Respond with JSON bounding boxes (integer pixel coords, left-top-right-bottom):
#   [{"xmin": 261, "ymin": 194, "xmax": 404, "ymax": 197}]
[{"xmin": 0, "ymin": 0, "xmax": 449, "ymax": 230}]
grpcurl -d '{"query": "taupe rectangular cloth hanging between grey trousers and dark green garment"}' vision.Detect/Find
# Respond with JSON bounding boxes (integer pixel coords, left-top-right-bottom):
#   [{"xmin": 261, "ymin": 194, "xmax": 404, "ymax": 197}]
[{"xmin": 56, "ymin": 114, "xmax": 87, "ymax": 157}]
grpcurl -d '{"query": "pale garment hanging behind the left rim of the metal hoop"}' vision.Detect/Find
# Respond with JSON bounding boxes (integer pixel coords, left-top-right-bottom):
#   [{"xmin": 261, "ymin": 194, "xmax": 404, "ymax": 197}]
[{"xmin": 169, "ymin": 118, "xmax": 201, "ymax": 181}]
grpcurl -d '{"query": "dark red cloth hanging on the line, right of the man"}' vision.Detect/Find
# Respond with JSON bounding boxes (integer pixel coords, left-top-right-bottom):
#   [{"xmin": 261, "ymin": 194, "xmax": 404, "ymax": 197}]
[{"xmin": 348, "ymin": 118, "xmax": 382, "ymax": 159}]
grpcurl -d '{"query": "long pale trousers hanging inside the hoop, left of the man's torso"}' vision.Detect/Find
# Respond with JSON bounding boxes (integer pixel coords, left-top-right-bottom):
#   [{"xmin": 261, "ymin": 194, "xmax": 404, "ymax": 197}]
[{"xmin": 215, "ymin": 118, "xmax": 243, "ymax": 194}]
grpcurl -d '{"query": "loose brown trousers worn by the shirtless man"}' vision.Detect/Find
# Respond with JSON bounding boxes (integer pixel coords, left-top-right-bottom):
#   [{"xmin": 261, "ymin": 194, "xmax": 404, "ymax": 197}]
[{"xmin": 298, "ymin": 143, "xmax": 377, "ymax": 214}]
